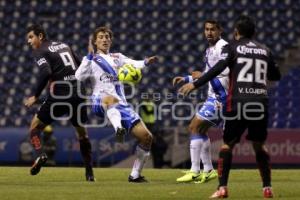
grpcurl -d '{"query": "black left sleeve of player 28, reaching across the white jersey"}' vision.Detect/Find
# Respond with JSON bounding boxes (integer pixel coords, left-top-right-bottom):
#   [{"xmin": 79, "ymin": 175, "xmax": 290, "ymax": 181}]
[{"xmin": 194, "ymin": 45, "xmax": 234, "ymax": 88}]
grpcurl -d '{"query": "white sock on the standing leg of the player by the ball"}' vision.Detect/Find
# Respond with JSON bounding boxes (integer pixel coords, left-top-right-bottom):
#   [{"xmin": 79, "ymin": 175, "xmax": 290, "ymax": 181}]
[{"xmin": 130, "ymin": 145, "xmax": 150, "ymax": 179}]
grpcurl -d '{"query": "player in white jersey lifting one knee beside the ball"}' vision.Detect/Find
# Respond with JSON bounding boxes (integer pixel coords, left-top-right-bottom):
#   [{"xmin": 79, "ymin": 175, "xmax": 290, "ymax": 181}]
[{"xmin": 75, "ymin": 27, "xmax": 157, "ymax": 182}]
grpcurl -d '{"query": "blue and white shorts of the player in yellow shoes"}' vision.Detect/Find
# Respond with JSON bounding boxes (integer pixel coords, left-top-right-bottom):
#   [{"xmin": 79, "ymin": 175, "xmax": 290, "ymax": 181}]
[{"xmin": 196, "ymin": 97, "xmax": 226, "ymax": 126}]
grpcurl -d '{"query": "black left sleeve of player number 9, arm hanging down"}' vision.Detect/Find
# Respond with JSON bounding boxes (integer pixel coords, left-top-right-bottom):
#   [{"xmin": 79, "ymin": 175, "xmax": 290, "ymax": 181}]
[{"xmin": 34, "ymin": 51, "xmax": 52, "ymax": 97}]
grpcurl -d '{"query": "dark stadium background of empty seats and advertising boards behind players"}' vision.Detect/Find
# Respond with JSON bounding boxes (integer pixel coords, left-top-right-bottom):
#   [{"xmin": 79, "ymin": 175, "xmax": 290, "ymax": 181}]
[{"xmin": 0, "ymin": 0, "xmax": 300, "ymax": 167}]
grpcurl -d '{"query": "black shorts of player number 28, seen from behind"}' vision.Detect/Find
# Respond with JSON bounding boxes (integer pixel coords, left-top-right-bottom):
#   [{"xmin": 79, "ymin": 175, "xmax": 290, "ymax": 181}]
[{"xmin": 223, "ymin": 112, "xmax": 268, "ymax": 145}]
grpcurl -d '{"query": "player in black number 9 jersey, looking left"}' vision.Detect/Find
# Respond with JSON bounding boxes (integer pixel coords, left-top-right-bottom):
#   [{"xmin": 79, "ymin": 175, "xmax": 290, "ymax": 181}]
[{"xmin": 25, "ymin": 24, "xmax": 95, "ymax": 181}]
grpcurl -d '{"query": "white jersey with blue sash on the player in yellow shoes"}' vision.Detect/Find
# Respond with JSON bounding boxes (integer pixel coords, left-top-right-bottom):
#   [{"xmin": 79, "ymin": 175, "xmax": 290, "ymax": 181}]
[{"xmin": 205, "ymin": 39, "xmax": 229, "ymax": 99}]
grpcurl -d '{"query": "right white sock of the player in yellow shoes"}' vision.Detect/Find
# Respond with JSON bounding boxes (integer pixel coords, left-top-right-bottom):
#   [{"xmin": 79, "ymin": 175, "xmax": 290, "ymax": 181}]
[{"xmin": 200, "ymin": 136, "xmax": 214, "ymax": 172}]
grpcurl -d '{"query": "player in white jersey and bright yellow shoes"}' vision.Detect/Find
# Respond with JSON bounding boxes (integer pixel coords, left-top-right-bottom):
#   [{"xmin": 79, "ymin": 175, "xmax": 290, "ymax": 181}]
[{"xmin": 173, "ymin": 20, "xmax": 229, "ymax": 183}]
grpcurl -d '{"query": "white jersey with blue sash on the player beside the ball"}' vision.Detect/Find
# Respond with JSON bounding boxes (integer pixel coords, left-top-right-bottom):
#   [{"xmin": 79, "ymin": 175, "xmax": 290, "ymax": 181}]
[{"xmin": 75, "ymin": 53, "xmax": 145, "ymax": 105}]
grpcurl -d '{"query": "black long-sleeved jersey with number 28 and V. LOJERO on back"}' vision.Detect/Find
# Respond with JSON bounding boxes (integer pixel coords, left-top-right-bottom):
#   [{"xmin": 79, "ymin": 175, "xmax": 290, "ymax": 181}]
[{"xmin": 194, "ymin": 38, "xmax": 280, "ymax": 112}]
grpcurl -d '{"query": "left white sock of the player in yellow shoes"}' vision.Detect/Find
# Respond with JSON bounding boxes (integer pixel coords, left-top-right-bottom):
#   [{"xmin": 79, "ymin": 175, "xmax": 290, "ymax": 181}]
[{"xmin": 190, "ymin": 136, "xmax": 202, "ymax": 173}]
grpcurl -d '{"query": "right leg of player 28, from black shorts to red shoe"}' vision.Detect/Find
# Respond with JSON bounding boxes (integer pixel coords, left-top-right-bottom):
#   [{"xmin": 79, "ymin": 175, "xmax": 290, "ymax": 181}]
[{"xmin": 247, "ymin": 113, "xmax": 273, "ymax": 198}]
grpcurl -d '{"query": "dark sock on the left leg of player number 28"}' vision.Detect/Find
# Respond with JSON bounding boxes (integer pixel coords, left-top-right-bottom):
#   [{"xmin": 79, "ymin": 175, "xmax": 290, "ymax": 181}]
[{"xmin": 218, "ymin": 149, "xmax": 232, "ymax": 187}]
